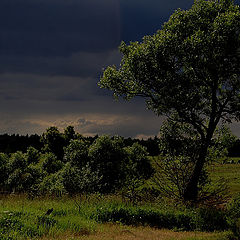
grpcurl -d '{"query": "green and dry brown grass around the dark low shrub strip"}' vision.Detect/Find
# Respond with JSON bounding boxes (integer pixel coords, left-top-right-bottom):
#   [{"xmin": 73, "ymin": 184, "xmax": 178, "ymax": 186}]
[{"xmin": 0, "ymin": 195, "xmax": 229, "ymax": 240}]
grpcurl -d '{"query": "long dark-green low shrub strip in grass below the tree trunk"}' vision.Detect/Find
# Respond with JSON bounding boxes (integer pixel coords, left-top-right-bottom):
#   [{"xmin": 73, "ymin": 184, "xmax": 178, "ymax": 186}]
[{"xmin": 92, "ymin": 203, "xmax": 228, "ymax": 231}]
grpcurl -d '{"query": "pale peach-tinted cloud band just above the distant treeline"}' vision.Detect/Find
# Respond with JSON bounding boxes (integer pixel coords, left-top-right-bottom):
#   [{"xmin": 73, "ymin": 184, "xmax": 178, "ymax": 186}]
[{"xmin": 0, "ymin": 113, "xmax": 162, "ymax": 138}]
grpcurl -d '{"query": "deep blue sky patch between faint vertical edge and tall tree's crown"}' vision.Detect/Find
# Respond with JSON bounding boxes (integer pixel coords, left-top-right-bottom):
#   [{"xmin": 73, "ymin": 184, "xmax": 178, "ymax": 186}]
[{"xmin": 121, "ymin": 0, "xmax": 193, "ymax": 42}]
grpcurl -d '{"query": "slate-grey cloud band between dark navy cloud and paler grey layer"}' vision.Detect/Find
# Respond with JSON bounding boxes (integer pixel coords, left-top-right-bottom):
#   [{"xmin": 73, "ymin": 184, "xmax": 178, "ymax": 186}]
[{"xmin": 0, "ymin": 49, "xmax": 121, "ymax": 77}]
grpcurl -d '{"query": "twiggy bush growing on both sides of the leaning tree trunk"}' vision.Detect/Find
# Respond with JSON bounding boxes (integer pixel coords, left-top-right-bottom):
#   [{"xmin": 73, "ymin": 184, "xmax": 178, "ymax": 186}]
[{"xmin": 151, "ymin": 121, "xmax": 231, "ymax": 204}]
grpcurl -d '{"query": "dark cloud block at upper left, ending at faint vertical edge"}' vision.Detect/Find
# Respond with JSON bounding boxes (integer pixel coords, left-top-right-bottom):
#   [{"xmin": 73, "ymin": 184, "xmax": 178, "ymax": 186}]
[{"xmin": 0, "ymin": 0, "xmax": 119, "ymax": 56}]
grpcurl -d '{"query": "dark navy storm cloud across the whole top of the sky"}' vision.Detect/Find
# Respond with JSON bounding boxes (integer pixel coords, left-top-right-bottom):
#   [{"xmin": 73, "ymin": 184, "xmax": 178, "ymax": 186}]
[{"xmin": 0, "ymin": 0, "xmax": 192, "ymax": 59}]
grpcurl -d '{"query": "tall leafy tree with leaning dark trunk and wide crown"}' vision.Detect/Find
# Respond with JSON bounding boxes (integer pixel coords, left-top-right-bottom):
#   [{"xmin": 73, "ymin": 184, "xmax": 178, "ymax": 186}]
[{"xmin": 99, "ymin": 0, "xmax": 240, "ymax": 200}]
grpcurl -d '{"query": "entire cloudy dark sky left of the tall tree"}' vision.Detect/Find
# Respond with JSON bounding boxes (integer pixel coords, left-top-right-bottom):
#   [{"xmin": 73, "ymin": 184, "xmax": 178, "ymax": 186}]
[{"xmin": 0, "ymin": 0, "xmax": 240, "ymax": 138}]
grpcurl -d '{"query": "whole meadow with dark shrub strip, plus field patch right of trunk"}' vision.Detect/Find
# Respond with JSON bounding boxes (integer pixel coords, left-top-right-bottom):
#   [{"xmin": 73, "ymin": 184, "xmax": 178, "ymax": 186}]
[{"xmin": 0, "ymin": 159, "xmax": 240, "ymax": 240}]
